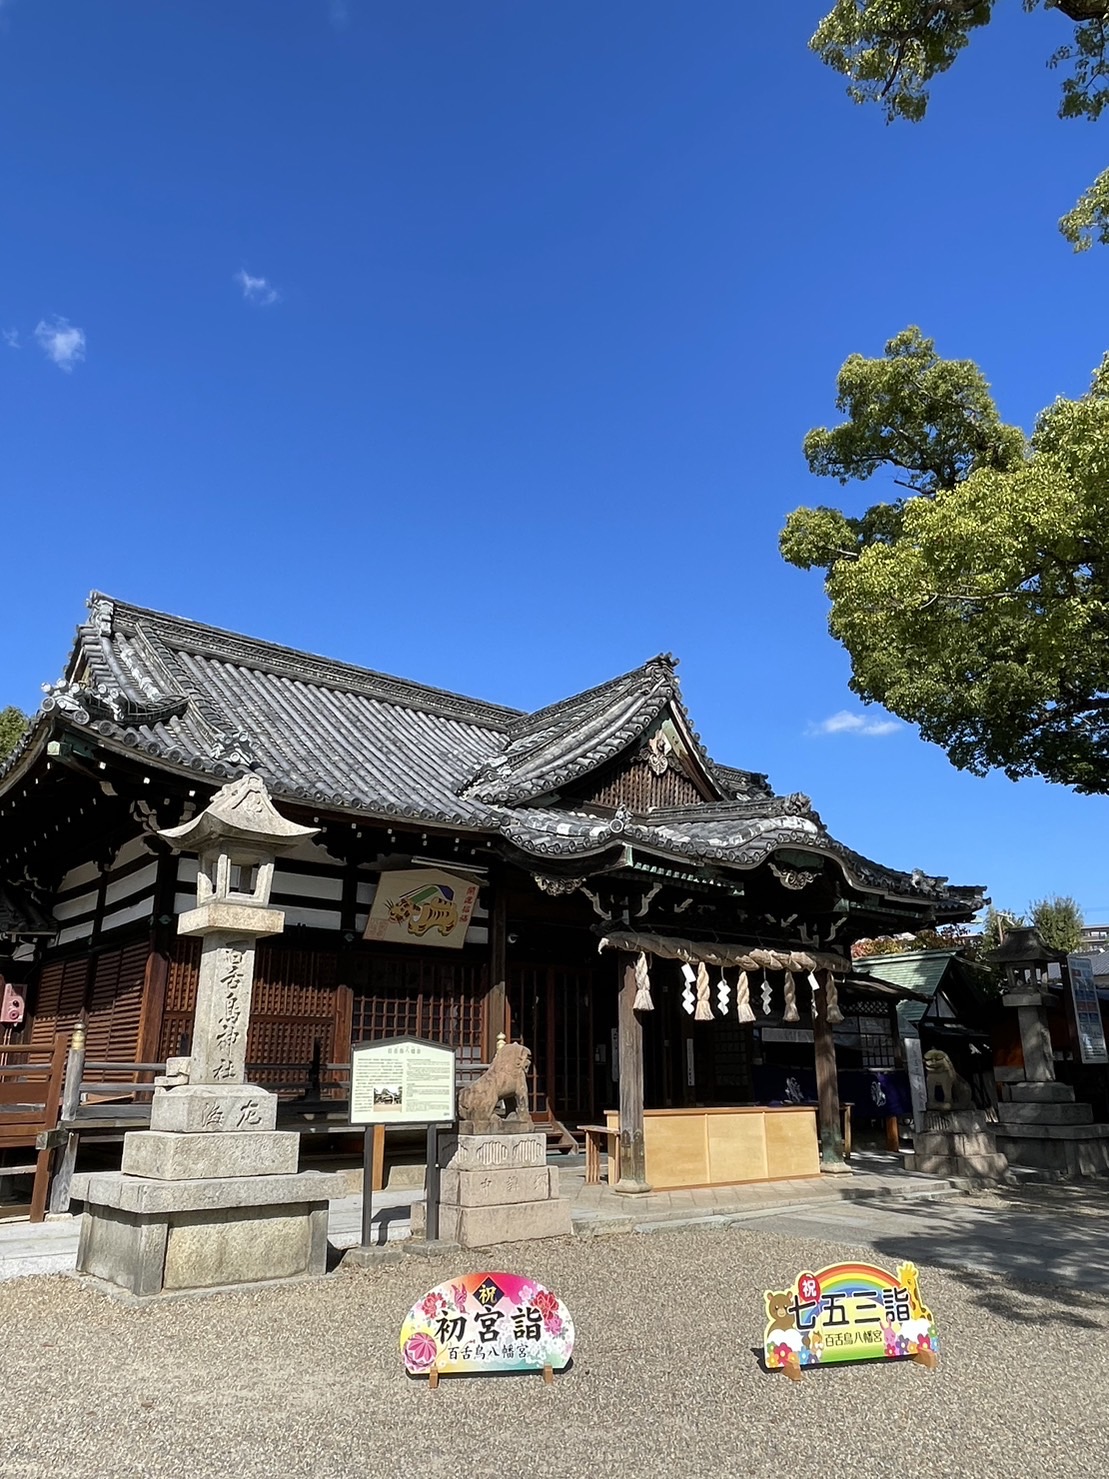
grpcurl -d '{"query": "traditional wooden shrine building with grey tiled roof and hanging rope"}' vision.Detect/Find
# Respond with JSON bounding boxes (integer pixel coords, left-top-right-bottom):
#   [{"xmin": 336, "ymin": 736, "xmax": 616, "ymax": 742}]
[{"xmin": 0, "ymin": 595, "xmax": 982, "ymax": 1185}]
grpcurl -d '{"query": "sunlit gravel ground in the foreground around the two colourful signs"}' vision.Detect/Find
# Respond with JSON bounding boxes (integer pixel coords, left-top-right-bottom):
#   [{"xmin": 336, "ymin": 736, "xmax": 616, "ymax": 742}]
[{"xmin": 0, "ymin": 1228, "xmax": 1109, "ymax": 1479}]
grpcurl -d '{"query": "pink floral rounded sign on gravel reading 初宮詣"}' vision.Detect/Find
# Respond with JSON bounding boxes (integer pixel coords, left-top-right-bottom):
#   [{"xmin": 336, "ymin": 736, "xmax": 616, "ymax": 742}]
[{"xmin": 401, "ymin": 1273, "xmax": 574, "ymax": 1386}]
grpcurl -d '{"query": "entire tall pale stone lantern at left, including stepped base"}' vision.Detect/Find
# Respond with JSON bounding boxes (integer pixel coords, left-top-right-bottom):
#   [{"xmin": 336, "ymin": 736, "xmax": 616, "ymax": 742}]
[{"xmin": 77, "ymin": 775, "xmax": 343, "ymax": 1302}]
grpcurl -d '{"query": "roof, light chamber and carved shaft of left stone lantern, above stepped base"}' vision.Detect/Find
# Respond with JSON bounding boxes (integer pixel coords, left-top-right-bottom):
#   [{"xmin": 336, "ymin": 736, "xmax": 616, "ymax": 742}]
[{"xmin": 158, "ymin": 775, "xmax": 318, "ymax": 1086}]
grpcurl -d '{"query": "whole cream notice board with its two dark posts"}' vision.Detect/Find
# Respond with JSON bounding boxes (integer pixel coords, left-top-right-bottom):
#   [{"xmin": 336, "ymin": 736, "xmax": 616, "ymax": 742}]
[{"xmin": 350, "ymin": 1037, "xmax": 455, "ymax": 1248}]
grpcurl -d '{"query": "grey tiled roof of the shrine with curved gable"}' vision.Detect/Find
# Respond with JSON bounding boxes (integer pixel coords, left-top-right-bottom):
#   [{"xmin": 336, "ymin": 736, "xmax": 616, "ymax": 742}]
[{"xmin": 0, "ymin": 595, "xmax": 980, "ymax": 914}]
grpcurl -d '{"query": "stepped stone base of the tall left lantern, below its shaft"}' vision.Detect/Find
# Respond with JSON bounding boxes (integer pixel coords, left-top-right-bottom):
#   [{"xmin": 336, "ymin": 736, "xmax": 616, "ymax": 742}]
[{"xmin": 74, "ymin": 1084, "xmax": 343, "ymax": 1300}]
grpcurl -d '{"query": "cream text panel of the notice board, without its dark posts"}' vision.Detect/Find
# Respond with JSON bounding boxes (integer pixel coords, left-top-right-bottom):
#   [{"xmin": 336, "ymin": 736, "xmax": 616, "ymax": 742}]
[{"xmin": 350, "ymin": 1037, "xmax": 457, "ymax": 1124}]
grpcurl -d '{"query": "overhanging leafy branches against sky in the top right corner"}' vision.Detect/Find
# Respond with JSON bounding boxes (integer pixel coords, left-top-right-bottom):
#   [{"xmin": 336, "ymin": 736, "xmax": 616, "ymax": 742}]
[{"xmin": 809, "ymin": 0, "xmax": 1109, "ymax": 251}]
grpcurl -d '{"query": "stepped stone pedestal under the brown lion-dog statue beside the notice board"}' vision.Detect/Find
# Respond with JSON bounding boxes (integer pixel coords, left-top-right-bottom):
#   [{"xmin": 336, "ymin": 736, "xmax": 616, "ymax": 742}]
[{"xmin": 413, "ymin": 1134, "xmax": 574, "ymax": 1248}]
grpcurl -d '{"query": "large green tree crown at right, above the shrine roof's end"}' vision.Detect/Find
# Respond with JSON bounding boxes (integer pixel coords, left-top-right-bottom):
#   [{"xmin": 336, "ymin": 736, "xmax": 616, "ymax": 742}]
[{"xmin": 781, "ymin": 328, "xmax": 1109, "ymax": 793}]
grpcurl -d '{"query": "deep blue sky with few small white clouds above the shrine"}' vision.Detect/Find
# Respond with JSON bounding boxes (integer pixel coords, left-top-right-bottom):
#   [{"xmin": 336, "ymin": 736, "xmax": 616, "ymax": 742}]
[{"xmin": 0, "ymin": 0, "xmax": 1109, "ymax": 918}]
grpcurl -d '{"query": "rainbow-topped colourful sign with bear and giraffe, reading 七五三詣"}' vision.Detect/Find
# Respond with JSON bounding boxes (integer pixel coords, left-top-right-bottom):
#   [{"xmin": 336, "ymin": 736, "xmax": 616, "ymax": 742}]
[{"xmin": 763, "ymin": 1263, "xmax": 939, "ymax": 1378}]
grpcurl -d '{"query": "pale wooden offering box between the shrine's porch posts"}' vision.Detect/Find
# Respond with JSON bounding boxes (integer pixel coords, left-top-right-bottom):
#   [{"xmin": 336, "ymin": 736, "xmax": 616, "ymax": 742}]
[{"xmin": 605, "ymin": 1106, "xmax": 821, "ymax": 1191}]
